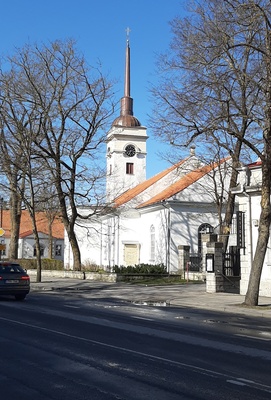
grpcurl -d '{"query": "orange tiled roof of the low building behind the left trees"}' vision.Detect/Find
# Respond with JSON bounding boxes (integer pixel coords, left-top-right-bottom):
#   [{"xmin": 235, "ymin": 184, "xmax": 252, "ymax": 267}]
[{"xmin": 2, "ymin": 210, "xmax": 64, "ymax": 239}]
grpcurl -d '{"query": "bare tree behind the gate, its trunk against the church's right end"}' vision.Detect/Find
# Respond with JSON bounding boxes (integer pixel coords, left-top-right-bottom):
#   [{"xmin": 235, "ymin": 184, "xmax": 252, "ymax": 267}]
[{"xmin": 152, "ymin": 0, "xmax": 262, "ymax": 250}]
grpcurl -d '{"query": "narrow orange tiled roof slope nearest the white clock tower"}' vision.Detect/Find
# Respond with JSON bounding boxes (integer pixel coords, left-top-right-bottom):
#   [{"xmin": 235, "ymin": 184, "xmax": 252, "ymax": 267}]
[{"xmin": 114, "ymin": 158, "xmax": 188, "ymax": 207}]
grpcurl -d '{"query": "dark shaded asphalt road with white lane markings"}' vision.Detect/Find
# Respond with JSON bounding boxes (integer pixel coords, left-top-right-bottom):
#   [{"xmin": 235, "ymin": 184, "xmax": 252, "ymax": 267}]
[{"xmin": 0, "ymin": 292, "xmax": 271, "ymax": 400}]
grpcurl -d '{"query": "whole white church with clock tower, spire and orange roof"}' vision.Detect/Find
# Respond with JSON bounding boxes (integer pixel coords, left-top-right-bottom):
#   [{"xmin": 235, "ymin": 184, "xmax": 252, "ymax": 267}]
[{"xmin": 64, "ymin": 37, "xmax": 234, "ymax": 273}]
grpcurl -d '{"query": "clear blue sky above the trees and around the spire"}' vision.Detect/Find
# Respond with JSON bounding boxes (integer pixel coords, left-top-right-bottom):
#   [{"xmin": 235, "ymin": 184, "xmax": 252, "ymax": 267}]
[{"xmin": 0, "ymin": 0, "xmax": 187, "ymax": 177}]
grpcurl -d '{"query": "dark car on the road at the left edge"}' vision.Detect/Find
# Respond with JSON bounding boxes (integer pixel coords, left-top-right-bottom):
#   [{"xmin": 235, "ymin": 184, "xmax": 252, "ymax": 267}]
[{"xmin": 0, "ymin": 261, "xmax": 30, "ymax": 300}]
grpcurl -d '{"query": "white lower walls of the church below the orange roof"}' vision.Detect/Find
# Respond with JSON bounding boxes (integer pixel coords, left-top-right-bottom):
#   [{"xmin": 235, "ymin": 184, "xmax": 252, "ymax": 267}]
[{"xmin": 67, "ymin": 201, "xmax": 227, "ymax": 273}]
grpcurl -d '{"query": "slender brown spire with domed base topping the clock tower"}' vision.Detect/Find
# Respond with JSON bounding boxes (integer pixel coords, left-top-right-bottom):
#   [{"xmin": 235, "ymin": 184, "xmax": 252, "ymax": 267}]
[{"xmin": 112, "ymin": 28, "xmax": 141, "ymax": 128}]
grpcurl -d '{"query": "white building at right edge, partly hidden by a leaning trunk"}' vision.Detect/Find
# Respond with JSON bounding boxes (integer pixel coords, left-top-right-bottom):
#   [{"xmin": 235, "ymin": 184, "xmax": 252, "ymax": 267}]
[{"xmin": 233, "ymin": 161, "xmax": 271, "ymax": 296}]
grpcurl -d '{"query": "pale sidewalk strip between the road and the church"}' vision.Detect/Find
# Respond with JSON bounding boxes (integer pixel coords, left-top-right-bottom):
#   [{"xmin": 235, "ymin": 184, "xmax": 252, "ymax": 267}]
[{"xmin": 31, "ymin": 278, "xmax": 271, "ymax": 318}]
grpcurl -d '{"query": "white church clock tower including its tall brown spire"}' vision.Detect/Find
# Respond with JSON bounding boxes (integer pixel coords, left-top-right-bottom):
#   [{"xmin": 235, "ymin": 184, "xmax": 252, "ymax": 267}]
[{"xmin": 106, "ymin": 34, "xmax": 148, "ymax": 202}]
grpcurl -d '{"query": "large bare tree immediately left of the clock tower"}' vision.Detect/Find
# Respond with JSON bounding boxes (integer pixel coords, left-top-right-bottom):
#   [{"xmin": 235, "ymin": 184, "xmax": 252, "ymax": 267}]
[{"xmin": 1, "ymin": 40, "xmax": 114, "ymax": 270}]
